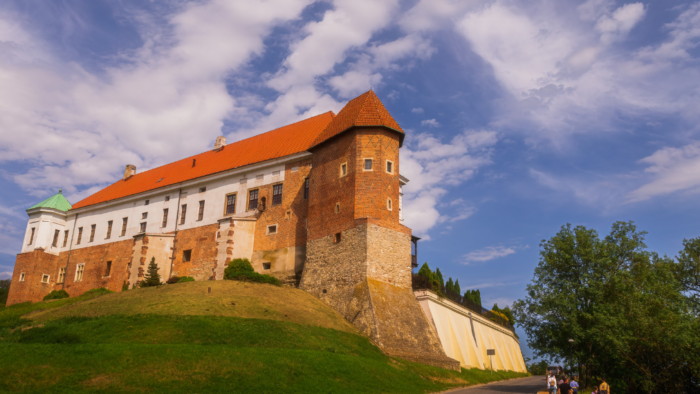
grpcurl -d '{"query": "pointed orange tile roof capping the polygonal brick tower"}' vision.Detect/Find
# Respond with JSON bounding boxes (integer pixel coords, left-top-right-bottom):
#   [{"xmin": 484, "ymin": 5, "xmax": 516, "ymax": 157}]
[{"xmin": 311, "ymin": 90, "xmax": 405, "ymax": 147}]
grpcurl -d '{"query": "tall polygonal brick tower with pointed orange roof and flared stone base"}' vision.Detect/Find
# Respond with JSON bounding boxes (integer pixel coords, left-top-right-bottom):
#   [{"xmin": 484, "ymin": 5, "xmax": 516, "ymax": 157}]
[{"xmin": 300, "ymin": 91, "xmax": 459, "ymax": 369}]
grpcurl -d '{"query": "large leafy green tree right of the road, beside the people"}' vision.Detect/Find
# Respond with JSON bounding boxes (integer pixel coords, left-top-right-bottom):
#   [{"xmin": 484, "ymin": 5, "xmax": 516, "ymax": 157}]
[{"xmin": 513, "ymin": 222, "xmax": 700, "ymax": 393}]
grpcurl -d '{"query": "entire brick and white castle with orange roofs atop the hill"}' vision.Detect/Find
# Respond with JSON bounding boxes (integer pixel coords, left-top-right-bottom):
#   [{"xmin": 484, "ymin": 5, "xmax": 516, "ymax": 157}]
[{"xmin": 7, "ymin": 91, "xmax": 522, "ymax": 369}]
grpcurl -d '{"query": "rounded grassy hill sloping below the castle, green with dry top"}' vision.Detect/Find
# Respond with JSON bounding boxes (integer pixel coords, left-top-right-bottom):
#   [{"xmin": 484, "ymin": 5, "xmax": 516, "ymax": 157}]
[{"xmin": 0, "ymin": 281, "xmax": 524, "ymax": 393}]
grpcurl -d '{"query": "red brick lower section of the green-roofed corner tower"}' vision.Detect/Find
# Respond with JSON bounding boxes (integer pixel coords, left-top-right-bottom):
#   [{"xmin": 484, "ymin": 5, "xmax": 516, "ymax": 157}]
[{"xmin": 6, "ymin": 248, "xmax": 58, "ymax": 306}]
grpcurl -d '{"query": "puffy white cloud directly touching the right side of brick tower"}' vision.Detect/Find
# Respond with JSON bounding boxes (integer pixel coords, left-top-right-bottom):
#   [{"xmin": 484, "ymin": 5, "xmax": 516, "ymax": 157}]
[{"xmin": 400, "ymin": 131, "xmax": 498, "ymax": 239}]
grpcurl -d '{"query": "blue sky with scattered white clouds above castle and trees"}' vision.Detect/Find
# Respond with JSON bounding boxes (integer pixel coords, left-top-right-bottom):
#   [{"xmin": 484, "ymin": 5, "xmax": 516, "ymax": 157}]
[{"xmin": 0, "ymin": 0, "xmax": 700, "ymax": 362}]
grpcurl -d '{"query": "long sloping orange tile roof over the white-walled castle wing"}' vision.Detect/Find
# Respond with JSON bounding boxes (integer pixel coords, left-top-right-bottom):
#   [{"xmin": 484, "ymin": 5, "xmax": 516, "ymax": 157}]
[{"xmin": 73, "ymin": 109, "xmax": 334, "ymax": 209}]
